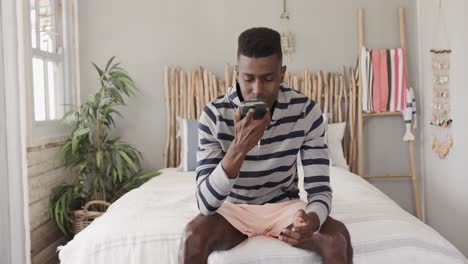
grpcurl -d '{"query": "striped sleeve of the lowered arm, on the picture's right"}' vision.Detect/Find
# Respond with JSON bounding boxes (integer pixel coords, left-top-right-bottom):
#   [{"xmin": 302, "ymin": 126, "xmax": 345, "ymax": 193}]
[{"xmin": 301, "ymin": 101, "xmax": 332, "ymax": 226}]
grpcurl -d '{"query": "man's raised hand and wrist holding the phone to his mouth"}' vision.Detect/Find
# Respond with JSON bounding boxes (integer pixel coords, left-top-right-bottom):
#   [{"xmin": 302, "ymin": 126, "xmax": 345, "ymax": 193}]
[{"xmin": 221, "ymin": 108, "xmax": 271, "ymax": 179}]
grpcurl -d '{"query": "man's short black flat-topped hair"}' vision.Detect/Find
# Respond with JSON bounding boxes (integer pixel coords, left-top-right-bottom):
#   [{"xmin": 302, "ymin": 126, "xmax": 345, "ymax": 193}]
[{"xmin": 237, "ymin": 27, "xmax": 283, "ymax": 60}]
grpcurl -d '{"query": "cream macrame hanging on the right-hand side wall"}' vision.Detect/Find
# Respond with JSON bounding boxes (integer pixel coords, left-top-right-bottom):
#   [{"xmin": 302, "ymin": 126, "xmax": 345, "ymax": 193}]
[{"xmin": 430, "ymin": 0, "xmax": 453, "ymax": 159}]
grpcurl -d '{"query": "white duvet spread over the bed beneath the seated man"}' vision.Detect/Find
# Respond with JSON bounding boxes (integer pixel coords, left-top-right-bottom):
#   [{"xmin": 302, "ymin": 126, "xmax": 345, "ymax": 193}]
[{"xmin": 59, "ymin": 167, "xmax": 468, "ymax": 264}]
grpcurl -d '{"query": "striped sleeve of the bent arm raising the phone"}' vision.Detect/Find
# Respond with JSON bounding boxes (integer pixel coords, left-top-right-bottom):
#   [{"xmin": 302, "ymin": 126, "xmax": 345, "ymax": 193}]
[{"xmin": 196, "ymin": 105, "xmax": 236, "ymax": 215}]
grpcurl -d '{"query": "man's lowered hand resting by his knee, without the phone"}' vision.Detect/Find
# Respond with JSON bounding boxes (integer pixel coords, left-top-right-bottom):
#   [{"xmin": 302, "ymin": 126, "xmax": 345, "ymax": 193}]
[{"xmin": 278, "ymin": 209, "xmax": 320, "ymax": 248}]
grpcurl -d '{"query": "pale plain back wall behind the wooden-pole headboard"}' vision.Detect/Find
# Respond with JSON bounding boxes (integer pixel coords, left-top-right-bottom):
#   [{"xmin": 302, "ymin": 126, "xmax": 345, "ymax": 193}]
[{"xmin": 78, "ymin": 0, "xmax": 418, "ymax": 212}]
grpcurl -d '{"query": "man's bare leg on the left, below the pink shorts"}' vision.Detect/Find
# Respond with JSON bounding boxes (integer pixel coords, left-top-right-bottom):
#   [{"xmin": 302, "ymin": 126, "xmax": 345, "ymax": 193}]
[{"xmin": 179, "ymin": 213, "xmax": 247, "ymax": 264}]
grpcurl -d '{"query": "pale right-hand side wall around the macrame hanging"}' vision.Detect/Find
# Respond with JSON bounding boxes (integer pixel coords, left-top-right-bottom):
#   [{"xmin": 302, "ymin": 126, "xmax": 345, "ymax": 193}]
[{"xmin": 418, "ymin": 0, "xmax": 468, "ymax": 256}]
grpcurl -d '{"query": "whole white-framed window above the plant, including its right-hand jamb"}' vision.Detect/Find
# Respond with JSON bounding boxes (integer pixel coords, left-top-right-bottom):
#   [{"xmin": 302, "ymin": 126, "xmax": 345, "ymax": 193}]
[{"xmin": 29, "ymin": 0, "xmax": 76, "ymax": 122}]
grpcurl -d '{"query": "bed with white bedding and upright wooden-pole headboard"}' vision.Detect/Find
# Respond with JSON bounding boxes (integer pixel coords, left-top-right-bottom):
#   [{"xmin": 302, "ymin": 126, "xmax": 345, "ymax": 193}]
[{"xmin": 58, "ymin": 66, "xmax": 468, "ymax": 264}]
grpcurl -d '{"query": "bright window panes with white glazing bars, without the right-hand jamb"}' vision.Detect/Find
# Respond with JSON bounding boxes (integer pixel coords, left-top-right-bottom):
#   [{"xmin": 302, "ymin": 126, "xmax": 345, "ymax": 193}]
[{"xmin": 30, "ymin": 0, "xmax": 66, "ymax": 121}]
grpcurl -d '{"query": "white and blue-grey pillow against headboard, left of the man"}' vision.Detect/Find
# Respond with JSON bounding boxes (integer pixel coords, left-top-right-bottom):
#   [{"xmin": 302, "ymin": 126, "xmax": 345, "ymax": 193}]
[{"xmin": 177, "ymin": 117, "xmax": 198, "ymax": 171}]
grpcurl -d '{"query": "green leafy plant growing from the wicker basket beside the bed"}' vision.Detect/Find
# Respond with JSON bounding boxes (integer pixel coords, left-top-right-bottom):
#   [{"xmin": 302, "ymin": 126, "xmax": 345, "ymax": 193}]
[{"xmin": 51, "ymin": 57, "xmax": 160, "ymax": 235}]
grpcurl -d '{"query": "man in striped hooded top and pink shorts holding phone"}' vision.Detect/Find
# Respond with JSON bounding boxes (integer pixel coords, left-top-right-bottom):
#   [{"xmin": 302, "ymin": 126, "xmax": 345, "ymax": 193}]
[{"xmin": 179, "ymin": 28, "xmax": 352, "ymax": 263}]
